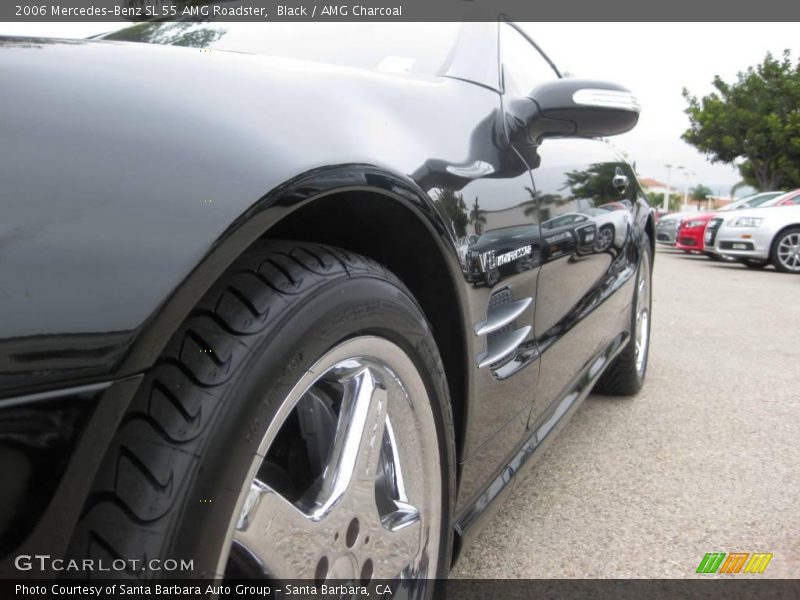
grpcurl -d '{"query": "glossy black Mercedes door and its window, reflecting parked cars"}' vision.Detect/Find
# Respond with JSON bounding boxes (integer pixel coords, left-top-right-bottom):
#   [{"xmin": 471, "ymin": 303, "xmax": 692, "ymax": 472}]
[{"xmin": 501, "ymin": 24, "xmax": 636, "ymax": 428}]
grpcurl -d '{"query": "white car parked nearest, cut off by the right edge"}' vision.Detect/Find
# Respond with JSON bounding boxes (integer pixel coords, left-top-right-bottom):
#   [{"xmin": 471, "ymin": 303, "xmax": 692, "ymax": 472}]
[{"xmin": 705, "ymin": 206, "xmax": 800, "ymax": 274}]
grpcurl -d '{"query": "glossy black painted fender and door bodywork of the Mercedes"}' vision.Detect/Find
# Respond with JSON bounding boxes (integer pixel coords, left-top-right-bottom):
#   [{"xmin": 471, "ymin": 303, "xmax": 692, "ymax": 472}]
[{"xmin": 0, "ymin": 23, "xmax": 651, "ymax": 564}]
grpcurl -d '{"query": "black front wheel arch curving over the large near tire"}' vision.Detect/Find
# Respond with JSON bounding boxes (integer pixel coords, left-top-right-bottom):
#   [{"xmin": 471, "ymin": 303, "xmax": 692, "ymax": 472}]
[{"xmin": 118, "ymin": 164, "xmax": 468, "ymax": 467}]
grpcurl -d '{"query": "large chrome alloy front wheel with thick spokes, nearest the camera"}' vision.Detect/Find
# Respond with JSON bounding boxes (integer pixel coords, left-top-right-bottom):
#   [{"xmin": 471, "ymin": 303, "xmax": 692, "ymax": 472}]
[{"xmin": 218, "ymin": 337, "xmax": 442, "ymax": 584}]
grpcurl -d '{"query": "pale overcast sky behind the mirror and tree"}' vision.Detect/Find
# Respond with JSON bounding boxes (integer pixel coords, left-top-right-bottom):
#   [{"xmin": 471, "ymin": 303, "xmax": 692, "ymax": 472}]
[{"xmin": 0, "ymin": 23, "xmax": 800, "ymax": 195}]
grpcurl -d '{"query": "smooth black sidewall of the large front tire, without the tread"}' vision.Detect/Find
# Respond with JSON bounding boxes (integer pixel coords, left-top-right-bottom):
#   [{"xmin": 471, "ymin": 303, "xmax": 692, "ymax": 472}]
[{"xmin": 165, "ymin": 276, "xmax": 454, "ymax": 577}]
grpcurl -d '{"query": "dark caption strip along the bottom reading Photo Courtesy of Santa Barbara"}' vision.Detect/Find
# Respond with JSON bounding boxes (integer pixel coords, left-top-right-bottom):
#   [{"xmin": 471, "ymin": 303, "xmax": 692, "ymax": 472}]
[{"xmin": 0, "ymin": 576, "xmax": 800, "ymax": 600}]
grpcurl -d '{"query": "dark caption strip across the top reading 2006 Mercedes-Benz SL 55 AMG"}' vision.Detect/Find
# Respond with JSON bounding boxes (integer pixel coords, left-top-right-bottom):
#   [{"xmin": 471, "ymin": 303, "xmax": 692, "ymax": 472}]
[{"xmin": 0, "ymin": 0, "xmax": 800, "ymax": 22}]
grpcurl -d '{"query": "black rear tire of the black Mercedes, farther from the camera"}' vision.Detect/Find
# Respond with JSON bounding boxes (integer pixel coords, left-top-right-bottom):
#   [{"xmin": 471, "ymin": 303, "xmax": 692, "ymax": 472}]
[{"xmin": 593, "ymin": 234, "xmax": 653, "ymax": 396}]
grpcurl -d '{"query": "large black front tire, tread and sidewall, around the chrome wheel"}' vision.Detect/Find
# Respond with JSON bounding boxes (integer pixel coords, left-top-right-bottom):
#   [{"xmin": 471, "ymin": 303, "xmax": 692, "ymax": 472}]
[{"xmin": 70, "ymin": 241, "xmax": 455, "ymax": 588}]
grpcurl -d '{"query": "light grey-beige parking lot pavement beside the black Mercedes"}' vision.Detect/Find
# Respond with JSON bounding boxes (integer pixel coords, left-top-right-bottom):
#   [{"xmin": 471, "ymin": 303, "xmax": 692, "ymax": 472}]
[{"xmin": 453, "ymin": 248, "xmax": 800, "ymax": 578}]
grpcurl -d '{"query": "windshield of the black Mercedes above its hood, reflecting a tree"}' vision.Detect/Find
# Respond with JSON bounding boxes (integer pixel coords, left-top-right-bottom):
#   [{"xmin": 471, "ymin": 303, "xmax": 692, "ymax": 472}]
[{"xmin": 101, "ymin": 22, "xmax": 460, "ymax": 76}]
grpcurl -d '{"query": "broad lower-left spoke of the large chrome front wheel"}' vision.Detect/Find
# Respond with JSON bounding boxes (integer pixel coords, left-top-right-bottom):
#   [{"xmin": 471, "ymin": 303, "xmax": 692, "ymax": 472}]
[{"xmin": 234, "ymin": 479, "xmax": 332, "ymax": 578}]
